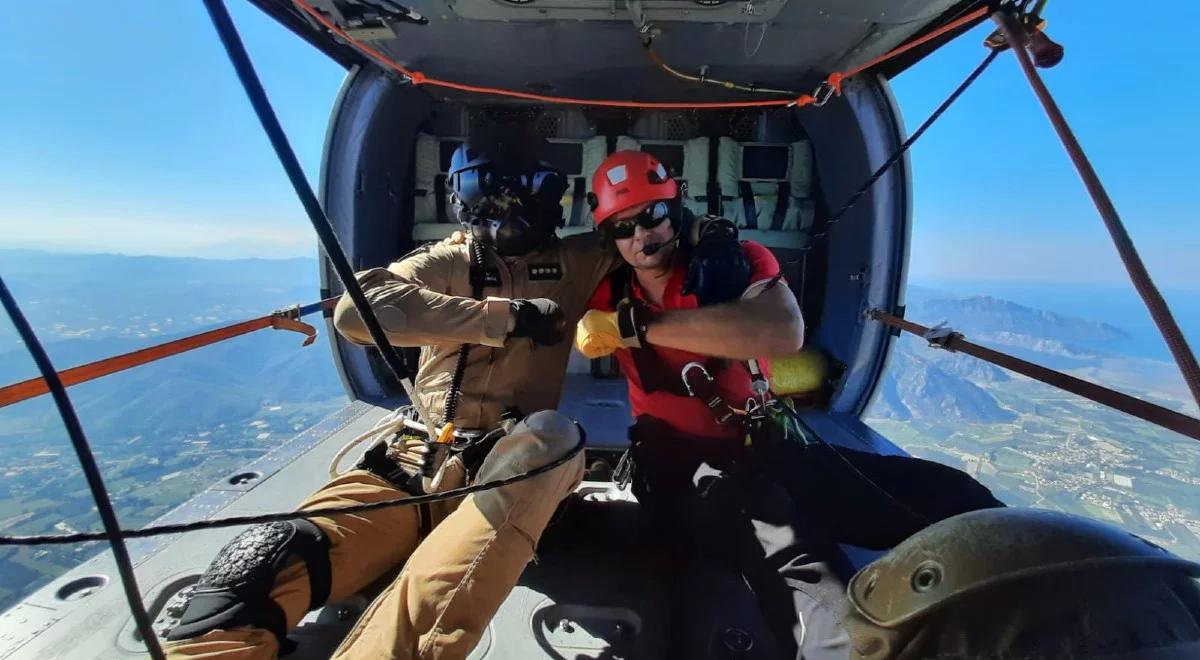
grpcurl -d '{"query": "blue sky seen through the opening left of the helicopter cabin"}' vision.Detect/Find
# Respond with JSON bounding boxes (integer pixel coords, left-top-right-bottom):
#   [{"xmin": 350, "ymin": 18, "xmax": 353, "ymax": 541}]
[{"xmin": 0, "ymin": 0, "xmax": 344, "ymax": 257}]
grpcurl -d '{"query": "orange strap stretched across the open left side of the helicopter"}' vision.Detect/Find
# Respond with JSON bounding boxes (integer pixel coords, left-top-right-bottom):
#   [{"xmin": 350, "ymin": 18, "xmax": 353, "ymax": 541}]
[{"xmin": 0, "ymin": 298, "xmax": 338, "ymax": 408}]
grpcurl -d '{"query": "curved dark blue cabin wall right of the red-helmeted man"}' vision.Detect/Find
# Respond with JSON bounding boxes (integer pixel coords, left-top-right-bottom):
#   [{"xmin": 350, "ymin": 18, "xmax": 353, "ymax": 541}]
[{"xmin": 800, "ymin": 78, "xmax": 911, "ymax": 416}]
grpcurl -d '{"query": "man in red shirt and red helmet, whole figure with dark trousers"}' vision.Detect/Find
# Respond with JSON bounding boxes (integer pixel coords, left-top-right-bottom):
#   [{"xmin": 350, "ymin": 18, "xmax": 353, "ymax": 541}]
[{"xmin": 576, "ymin": 151, "xmax": 1002, "ymax": 660}]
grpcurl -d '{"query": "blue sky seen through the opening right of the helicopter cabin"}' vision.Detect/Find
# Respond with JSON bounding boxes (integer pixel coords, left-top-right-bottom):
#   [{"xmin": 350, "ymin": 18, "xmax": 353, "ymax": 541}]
[{"xmin": 894, "ymin": 0, "xmax": 1200, "ymax": 289}]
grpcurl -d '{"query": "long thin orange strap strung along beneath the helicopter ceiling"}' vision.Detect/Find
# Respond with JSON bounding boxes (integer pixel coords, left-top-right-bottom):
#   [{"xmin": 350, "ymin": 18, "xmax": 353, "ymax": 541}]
[{"xmin": 293, "ymin": 0, "xmax": 988, "ymax": 110}]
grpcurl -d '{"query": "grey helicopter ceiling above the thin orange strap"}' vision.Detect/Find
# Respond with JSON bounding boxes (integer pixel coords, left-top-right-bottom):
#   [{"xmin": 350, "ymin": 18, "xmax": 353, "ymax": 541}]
[{"xmin": 253, "ymin": 0, "xmax": 978, "ymax": 102}]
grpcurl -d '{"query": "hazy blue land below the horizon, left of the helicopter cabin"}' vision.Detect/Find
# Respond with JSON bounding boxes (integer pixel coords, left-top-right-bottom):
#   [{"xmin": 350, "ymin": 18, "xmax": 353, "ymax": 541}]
[{"xmin": 0, "ymin": 250, "xmax": 346, "ymax": 611}]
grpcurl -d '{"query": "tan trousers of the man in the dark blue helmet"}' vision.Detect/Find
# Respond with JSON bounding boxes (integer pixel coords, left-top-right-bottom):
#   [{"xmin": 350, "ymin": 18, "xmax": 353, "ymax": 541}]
[{"xmin": 166, "ymin": 410, "xmax": 583, "ymax": 660}]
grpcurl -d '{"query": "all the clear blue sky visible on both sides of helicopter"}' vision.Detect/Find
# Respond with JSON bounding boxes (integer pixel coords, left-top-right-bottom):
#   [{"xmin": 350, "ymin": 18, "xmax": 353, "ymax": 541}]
[{"xmin": 0, "ymin": 0, "xmax": 1200, "ymax": 288}]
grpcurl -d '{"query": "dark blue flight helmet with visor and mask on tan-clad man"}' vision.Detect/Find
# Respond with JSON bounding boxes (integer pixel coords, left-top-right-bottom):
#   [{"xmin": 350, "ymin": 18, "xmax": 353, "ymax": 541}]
[{"xmin": 448, "ymin": 133, "xmax": 568, "ymax": 256}]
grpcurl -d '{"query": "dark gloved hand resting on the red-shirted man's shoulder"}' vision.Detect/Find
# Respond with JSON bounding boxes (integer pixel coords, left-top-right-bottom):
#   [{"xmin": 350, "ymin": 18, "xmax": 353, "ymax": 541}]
[{"xmin": 683, "ymin": 216, "xmax": 750, "ymax": 306}]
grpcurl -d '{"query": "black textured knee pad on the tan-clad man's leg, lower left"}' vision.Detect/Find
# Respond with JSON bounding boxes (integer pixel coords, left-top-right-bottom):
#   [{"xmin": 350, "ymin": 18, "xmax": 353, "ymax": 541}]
[{"xmin": 167, "ymin": 520, "xmax": 331, "ymax": 653}]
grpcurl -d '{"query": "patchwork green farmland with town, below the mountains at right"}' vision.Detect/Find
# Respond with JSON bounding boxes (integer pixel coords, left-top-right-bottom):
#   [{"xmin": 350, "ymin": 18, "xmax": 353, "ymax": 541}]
[{"xmin": 866, "ymin": 378, "xmax": 1200, "ymax": 560}]
